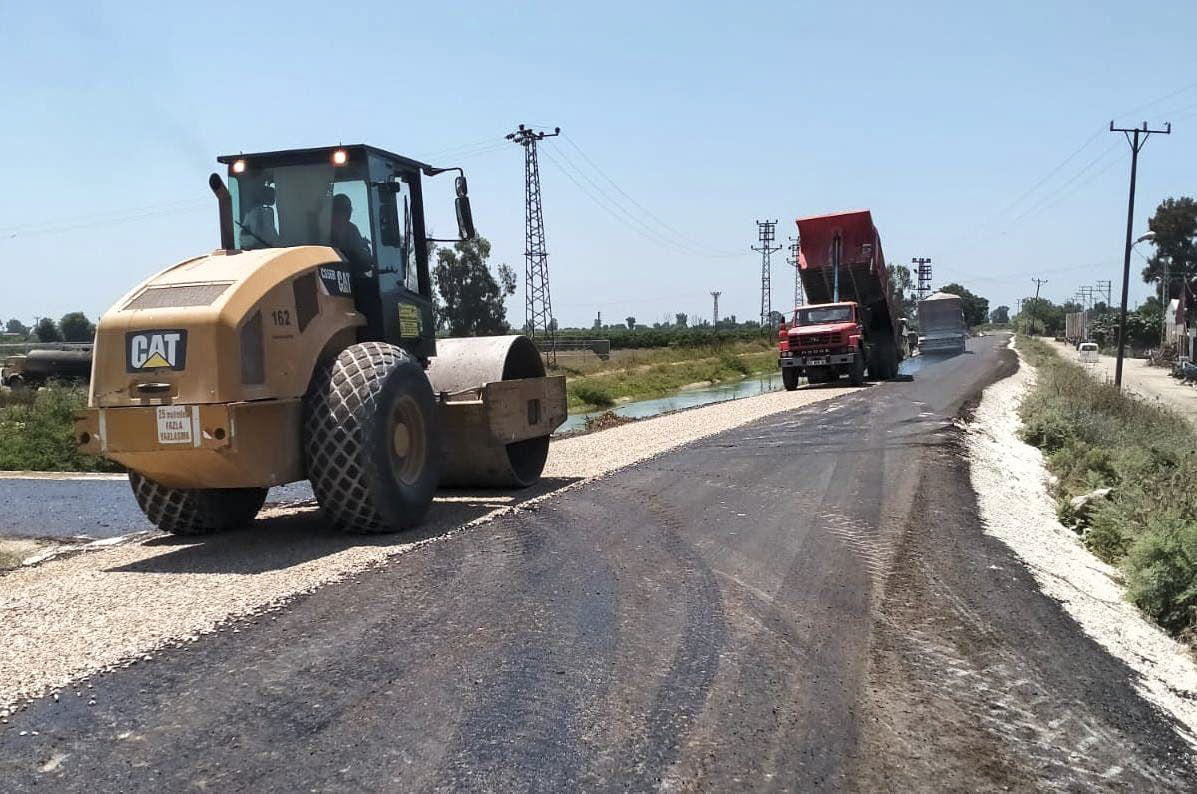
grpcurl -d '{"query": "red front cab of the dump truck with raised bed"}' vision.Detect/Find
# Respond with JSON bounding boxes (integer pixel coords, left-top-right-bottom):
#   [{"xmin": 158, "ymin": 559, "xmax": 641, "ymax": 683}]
[{"xmin": 778, "ymin": 301, "xmax": 868, "ymax": 390}]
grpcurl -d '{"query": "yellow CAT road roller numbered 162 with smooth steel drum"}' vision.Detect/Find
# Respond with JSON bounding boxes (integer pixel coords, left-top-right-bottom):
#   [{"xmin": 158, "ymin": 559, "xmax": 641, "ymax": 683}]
[{"xmin": 75, "ymin": 146, "xmax": 566, "ymax": 534}]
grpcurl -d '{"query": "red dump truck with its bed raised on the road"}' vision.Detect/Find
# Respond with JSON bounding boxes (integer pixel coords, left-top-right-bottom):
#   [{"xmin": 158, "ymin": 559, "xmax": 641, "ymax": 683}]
[{"xmin": 778, "ymin": 210, "xmax": 905, "ymax": 390}]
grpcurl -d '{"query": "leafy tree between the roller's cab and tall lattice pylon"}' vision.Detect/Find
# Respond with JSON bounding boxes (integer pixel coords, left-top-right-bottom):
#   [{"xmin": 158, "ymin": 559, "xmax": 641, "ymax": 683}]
[{"xmin": 435, "ymin": 237, "xmax": 516, "ymax": 337}]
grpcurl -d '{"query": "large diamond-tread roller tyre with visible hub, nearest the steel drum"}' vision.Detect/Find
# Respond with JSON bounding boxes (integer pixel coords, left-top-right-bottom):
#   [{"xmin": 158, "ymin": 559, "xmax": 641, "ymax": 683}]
[{"xmin": 304, "ymin": 341, "xmax": 440, "ymax": 532}]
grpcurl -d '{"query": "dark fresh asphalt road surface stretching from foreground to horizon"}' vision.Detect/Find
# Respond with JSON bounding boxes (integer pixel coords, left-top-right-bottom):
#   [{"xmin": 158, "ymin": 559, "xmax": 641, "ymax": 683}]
[{"xmin": 0, "ymin": 338, "xmax": 1197, "ymax": 792}]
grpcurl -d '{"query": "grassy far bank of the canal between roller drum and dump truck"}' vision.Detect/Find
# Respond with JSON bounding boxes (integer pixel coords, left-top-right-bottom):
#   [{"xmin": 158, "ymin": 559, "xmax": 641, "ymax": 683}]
[{"xmin": 567, "ymin": 345, "xmax": 777, "ymax": 411}]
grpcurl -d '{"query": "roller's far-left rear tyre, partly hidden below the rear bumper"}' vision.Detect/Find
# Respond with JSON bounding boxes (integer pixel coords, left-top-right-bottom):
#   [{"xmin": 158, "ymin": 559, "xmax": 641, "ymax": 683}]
[{"xmin": 129, "ymin": 472, "xmax": 266, "ymax": 535}]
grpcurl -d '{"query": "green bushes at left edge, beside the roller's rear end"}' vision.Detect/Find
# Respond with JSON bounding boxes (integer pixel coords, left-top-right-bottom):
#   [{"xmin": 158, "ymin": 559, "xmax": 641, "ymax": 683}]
[{"xmin": 0, "ymin": 384, "xmax": 123, "ymax": 472}]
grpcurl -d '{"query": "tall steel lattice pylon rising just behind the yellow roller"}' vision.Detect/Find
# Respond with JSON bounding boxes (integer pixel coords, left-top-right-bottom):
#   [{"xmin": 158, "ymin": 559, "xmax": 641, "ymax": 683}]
[{"xmin": 506, "ymin": 125, "xmax": 561, "ymax": 366}]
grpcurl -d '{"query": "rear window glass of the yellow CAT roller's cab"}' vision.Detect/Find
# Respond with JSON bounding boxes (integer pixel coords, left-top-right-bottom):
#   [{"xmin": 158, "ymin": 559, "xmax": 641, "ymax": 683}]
[{"xmin": 230, "ymin": 163, "xmax": 373, "ymax": 271}]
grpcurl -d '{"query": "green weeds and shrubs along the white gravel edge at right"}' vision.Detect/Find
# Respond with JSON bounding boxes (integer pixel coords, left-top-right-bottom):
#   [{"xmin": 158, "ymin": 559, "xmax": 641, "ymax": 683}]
[{"xmin": 1017, "ymin": 337, "xmax": 1197, "ymax": 643}]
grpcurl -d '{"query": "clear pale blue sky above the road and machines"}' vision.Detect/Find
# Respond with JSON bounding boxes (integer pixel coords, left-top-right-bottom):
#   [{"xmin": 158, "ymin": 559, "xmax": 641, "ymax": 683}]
[{"xmin": 0, "ymin": 0, "xmax": 1197, "ymax": 325}]
